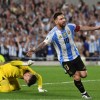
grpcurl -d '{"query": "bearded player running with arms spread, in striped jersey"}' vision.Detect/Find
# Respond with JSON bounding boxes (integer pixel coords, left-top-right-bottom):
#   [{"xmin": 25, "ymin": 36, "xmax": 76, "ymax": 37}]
[{"xmin": 27, "ymin": 12, "xmax": 100, "ymax": 99}]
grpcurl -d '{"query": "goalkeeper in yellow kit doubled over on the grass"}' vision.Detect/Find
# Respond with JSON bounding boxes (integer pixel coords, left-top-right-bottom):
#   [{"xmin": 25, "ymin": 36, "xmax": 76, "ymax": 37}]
[{"xmin": 0, "ymin": 60, "xmax": 47, "ymax": 92}]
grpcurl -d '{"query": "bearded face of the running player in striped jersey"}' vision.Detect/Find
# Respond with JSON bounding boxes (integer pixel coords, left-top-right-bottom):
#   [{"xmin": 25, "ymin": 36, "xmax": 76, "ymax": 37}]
[{"xmin": 55, "ymin": 15, "xmax": 66, "ymax": 28}]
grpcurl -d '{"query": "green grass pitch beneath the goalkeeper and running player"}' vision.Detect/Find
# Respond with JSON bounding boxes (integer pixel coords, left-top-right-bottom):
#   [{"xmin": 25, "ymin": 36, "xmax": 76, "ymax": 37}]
[{"xmin": 0, "ymin": 66, "xmax": 100, "ymax": 100}]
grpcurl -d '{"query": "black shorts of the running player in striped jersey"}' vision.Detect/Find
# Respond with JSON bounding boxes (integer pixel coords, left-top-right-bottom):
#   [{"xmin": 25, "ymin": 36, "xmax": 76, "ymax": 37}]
[{"xmin": 62, "ymin": 56, "xmax": 86, "ymax": 76}]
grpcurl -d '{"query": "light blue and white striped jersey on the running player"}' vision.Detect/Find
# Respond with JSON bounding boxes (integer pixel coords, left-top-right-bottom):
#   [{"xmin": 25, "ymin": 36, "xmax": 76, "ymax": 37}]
[{"xmin": 44, "ymin": 23, "xmax": 79, "ymax": 63}]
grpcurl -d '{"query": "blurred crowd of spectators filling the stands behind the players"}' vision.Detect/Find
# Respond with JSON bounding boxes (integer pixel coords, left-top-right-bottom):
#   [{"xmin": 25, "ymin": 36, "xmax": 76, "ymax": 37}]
[{"xmin": 0, "ymin": 0, "xmax": 100, "ymax": 60}]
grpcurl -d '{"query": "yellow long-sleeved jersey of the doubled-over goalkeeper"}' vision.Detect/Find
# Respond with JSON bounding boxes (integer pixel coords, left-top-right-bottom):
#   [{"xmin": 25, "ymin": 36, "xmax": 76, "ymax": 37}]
[{"xmin": 0, "ymin": 60, "xmax": 42, "ymax": 87}]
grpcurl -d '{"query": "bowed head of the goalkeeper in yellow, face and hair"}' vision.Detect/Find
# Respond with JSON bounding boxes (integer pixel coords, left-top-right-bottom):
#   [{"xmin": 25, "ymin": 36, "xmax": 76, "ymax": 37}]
[{"xmin": 23, "ymin": 71, "xmax": 37, "ymax": 87}]
